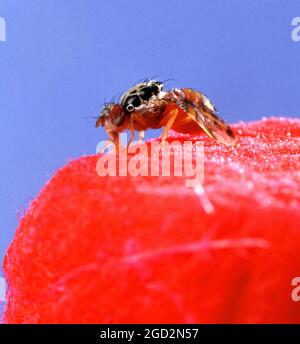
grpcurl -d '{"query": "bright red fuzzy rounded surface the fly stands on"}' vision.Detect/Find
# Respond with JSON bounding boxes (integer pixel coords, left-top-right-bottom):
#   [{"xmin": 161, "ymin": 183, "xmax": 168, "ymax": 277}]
[{"xmin": 4, "ymin": 119, "xmax": 300, "ymax": 323}]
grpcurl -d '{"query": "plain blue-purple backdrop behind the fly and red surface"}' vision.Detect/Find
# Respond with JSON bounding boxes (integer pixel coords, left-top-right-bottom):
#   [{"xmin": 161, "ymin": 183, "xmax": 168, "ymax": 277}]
[{"xmin": 0, "ymin": 0, "xmax": 300, "ymax": 282}]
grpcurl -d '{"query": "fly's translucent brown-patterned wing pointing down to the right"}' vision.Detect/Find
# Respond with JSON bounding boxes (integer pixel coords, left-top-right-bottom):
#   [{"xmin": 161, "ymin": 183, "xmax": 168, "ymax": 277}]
[{"xmin": 186, "ymin": 91, "xmax": 236, "ymax": 145}]
